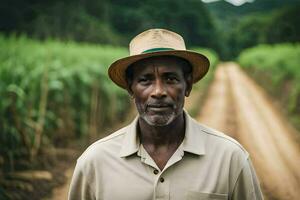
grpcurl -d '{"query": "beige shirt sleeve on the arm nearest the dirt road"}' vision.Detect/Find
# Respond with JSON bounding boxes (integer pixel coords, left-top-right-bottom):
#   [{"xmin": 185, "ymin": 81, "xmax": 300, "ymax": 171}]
[{"xmin": 231, "ymin": 157, "xmax": 264, "ymax": 200}]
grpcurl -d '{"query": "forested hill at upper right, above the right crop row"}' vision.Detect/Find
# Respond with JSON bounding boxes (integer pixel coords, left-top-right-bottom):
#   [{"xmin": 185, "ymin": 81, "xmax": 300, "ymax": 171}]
[{"xmin": 205, "ymin": 0, "xmax": 300, "ymax": 59}]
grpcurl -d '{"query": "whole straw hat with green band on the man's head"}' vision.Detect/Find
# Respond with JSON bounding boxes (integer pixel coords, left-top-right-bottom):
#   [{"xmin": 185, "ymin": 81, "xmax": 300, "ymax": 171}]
[{"xmin": 108, "ymin": 29, "xmax": 209, "ymax": 89}]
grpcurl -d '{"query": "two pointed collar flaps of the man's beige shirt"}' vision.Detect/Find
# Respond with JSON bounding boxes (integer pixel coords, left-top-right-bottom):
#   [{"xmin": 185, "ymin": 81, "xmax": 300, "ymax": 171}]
[{"xmin": 120, "ymin": 111, "xmax": 206, "ymax": 157}]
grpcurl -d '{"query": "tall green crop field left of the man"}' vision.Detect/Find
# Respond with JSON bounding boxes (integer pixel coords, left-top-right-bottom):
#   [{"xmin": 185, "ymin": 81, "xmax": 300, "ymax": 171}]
[{"xmin": 0, "ymin": 35, "xmax": 129, "ymax": 170}]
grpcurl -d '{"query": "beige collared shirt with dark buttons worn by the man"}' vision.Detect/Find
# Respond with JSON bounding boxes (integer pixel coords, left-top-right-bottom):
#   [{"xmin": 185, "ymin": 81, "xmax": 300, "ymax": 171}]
[{"xmin": 69, "ymin": 113, "xmax": 263, "ymax": 200}]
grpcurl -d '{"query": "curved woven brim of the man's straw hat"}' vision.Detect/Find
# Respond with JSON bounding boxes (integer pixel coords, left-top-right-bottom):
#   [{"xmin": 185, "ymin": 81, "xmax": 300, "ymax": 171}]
[{"xmin": 108, "ymin": 50, "xmax": 209, "ymax": 89}]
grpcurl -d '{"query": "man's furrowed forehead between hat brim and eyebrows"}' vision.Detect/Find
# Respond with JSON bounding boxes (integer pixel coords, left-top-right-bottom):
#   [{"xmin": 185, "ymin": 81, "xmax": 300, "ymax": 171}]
[{"xmin": 132, "ymin": 56, "xmax": 185, "ymax": 75}]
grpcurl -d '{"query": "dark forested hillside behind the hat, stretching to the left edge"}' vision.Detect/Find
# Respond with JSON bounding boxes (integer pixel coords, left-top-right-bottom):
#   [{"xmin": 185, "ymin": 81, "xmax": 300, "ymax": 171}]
[{"xmin": 0, "ymin": 0, "xmax": 218, "ymax": 48}]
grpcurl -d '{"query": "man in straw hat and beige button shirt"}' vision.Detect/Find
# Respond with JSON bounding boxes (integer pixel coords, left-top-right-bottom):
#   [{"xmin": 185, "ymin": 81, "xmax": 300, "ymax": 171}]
[{"xmin": 69, "ymin": 29, "xmax": 263, "ymax": 200}]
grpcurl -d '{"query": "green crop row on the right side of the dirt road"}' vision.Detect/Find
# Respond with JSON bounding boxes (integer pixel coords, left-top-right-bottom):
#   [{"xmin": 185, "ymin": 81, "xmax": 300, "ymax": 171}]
[{"xmin": 238, "ymin": 44, "xmax": 300, "ymax": 130}]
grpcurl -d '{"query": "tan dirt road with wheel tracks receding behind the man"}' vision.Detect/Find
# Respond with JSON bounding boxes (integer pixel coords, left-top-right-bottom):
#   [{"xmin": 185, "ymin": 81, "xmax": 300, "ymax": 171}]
[{"xmin": 197, "ymin": 63, "xmax": 300, "ymax": 200}]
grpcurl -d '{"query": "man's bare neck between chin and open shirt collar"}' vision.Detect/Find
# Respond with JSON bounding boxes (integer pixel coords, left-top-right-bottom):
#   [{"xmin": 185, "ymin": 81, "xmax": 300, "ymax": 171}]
[{"xmin": 138, "ymin": 113, "xmax": 185, "ymax": 147}]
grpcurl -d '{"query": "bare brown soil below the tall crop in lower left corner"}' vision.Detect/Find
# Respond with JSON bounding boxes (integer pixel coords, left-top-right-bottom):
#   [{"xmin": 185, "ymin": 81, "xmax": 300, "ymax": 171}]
[{"xmin": 0, "ymin": 148, "xmax": 79, "ymax": 200}]
